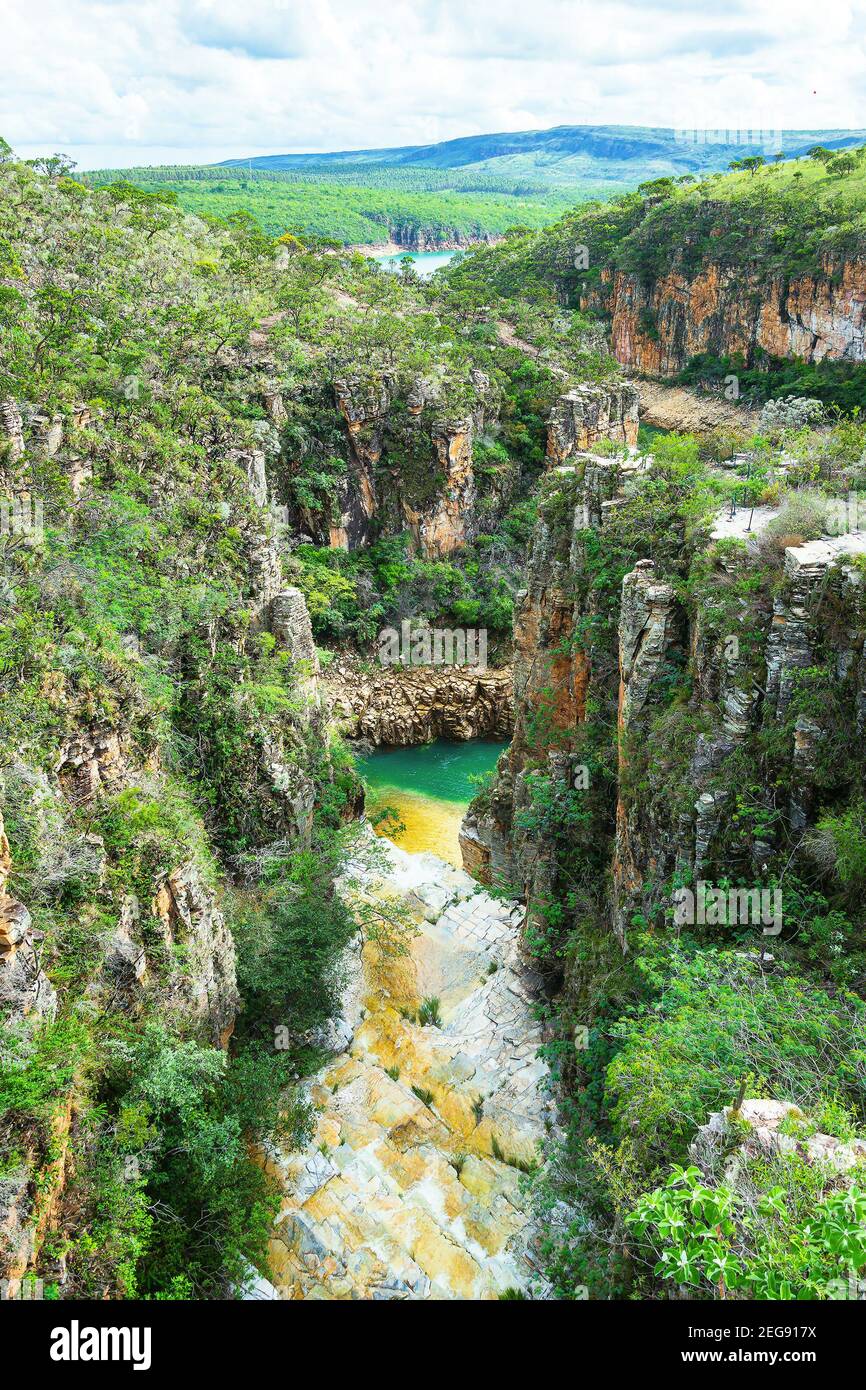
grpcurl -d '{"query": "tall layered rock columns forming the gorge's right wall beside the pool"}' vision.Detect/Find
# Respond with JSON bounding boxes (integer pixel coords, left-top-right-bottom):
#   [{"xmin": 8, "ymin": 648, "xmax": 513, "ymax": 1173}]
[{"xmin": 461, "ymin": 442, "xmax": 866, "ymax": 948}]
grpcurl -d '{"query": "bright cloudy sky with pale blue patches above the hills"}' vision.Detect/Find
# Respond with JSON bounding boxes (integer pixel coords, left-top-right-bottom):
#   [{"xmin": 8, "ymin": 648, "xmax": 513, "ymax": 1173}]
[{"xmin": 6, "ymin": 0, "xmax": 866, "ymax": 168}]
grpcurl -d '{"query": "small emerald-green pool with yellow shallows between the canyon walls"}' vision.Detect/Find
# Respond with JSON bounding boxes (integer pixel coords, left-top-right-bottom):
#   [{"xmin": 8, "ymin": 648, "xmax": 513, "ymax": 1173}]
[{"xmin": 357, "ymin": 738, "xmax": 507, "ymax": 867}]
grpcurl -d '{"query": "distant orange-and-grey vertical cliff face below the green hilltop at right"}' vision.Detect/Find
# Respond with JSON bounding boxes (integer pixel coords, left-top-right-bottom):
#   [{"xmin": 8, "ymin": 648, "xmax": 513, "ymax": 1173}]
[{"xmin": 581, "ymin": 259, "xmax": 866, "ymax": 375}]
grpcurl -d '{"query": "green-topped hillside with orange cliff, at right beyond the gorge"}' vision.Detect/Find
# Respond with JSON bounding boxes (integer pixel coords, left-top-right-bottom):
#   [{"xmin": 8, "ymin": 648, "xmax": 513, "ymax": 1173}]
[{"xmin": 439, "ymin": 145, "xmax": 866, "ymax": 409}]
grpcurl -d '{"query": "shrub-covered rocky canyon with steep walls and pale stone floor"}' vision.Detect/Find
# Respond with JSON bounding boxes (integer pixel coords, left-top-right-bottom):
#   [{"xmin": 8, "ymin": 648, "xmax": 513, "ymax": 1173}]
[{"xmin": 0, "ymin": 146, "xmax": 866, "ymax": 1301}]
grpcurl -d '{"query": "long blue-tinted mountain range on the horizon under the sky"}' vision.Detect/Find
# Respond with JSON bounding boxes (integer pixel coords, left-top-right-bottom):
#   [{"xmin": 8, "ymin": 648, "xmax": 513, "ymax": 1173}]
[{"xmin": 222, "ymin": 125, "xmax": 866, "ymax": 183}]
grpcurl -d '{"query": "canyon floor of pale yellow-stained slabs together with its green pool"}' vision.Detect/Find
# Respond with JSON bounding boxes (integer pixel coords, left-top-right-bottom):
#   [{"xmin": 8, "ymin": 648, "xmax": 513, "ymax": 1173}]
[{"xmin": 261, "ymin": 741, "xmax": 553, "ymax": 1300}]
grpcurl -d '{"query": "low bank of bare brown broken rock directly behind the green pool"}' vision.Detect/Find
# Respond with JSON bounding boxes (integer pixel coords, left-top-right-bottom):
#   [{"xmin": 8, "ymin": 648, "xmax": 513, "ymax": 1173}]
[{"xmin": 324, "ymin": 662, "xmax": 512, "ymax": 746}]
